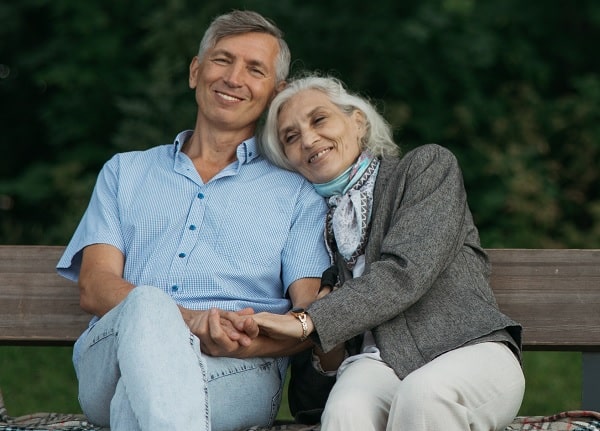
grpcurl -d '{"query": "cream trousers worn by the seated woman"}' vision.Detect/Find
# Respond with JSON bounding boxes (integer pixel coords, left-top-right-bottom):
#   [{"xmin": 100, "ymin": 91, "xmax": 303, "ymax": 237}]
[{"xmin": 321, "ymin": 342, "xmax": 525, "ymax": 431}]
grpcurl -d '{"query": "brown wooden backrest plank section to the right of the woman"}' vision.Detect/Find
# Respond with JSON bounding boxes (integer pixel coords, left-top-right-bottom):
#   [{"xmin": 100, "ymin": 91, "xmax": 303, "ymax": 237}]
[{"xmin": 488, "ymin": 249, "xmax": 600, "ymax": 351}]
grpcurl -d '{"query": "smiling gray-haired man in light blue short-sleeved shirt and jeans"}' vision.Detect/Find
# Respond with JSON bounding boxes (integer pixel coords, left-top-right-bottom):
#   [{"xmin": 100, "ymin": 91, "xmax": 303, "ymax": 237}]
[{"xmin": 57, "ymin": 11, "xmax": 329, "ymax": 431}]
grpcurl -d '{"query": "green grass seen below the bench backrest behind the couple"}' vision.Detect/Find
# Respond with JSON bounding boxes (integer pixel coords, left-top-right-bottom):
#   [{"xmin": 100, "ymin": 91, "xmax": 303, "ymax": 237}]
[{"xmin": 0, "ymin": 346, "xmax": 581, "ymax": 419}]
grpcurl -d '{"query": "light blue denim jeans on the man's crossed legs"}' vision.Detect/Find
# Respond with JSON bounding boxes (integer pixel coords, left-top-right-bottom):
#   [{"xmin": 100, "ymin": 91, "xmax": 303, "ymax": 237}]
[{"xmin": 73, "ymin": 286, "xmax": 283, "ymax": 431}]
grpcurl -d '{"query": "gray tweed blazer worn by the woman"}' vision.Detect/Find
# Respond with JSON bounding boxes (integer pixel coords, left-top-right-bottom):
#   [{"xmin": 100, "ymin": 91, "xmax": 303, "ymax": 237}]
[{"xmin": 307, "ymin": 145, "xmax": 521, "ymax": 378}]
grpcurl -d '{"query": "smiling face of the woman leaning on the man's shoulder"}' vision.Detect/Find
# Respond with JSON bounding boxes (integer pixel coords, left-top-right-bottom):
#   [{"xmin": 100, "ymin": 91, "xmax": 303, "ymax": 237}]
[{"xmin": 277, "ymin": 89, "xmax": 365, "ymax": 184}]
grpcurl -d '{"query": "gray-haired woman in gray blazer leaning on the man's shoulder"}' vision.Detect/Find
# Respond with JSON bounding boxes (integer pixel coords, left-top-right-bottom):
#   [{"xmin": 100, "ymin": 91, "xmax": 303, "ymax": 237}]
[{"xmin": 254, "ymin": 76, "xmax": 525, "ymax": 431}]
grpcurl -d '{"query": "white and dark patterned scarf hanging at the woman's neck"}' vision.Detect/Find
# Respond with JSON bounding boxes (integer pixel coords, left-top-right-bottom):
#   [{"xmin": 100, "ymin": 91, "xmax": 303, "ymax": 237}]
[{"xmin": 325, "ymin": 153, "xmax": 379, "ymax": 271}]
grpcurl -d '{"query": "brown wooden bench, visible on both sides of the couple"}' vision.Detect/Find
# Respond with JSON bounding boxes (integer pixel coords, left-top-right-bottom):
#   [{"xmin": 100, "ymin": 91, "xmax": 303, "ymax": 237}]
[{"xmin": 0, "ymin": 246, "xmax": 600, "ymax": 411}]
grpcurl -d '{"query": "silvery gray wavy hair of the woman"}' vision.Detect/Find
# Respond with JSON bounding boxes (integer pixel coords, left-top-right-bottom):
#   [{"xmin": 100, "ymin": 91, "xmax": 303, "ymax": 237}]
[{"xmin": 259, "ymin": 75, "xmax": 400, "ymax": 170}]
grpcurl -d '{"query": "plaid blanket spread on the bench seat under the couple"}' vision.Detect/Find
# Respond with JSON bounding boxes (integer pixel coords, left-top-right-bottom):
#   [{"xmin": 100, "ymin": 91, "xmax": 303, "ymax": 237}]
[{"xmin": 0, "ymin": 392, "xmax": 600, "ymax": 431}]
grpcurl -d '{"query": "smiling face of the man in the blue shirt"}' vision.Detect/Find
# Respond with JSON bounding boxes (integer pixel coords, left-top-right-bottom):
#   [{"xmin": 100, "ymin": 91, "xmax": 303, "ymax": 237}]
[{"xmin": 189, "ymin": 33, "xmax": 279, "ymax": 135}]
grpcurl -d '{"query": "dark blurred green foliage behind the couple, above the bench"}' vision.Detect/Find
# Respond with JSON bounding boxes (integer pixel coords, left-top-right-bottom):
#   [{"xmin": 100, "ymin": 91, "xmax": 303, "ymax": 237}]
[{"xmin": 0, "ymin": 0, "xmax": 600, "ymax": 247}]
